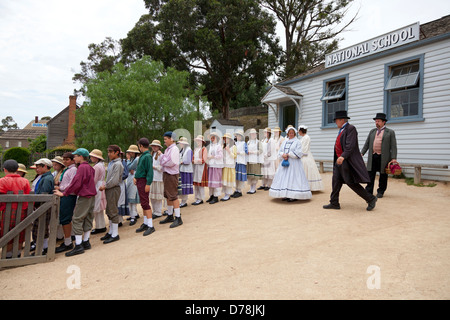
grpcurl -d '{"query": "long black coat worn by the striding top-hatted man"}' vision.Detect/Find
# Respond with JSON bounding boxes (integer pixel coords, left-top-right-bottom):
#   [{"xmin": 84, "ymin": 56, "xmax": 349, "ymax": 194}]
[{"xmin": 334, "ymin": 123, "xmax": 370, "ymax": 184}]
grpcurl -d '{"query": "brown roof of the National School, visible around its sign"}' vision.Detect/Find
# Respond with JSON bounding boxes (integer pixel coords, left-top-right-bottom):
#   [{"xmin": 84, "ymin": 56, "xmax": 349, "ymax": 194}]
[{"xmin": 277, "ymin": 15, "xmax": 450, "ymax": 86}]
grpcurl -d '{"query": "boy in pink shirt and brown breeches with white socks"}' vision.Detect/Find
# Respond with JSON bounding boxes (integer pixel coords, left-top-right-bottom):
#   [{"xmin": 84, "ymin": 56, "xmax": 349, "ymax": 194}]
[{"xmin": 158, "ymin": 131, "xmax": 183, "ymax": 228}]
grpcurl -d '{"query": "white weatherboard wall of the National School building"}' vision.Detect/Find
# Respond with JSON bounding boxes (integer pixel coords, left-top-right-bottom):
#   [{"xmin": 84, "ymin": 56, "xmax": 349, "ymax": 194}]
[{"xmin": 268, "ymin": 38, "xmax": 450, "ymax": 181}]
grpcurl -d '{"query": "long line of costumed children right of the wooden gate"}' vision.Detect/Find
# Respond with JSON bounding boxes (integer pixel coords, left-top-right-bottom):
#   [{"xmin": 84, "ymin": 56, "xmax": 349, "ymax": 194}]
[{"xmin": 4, "ymin": 128, "xmax": 320, "ymax": 256}]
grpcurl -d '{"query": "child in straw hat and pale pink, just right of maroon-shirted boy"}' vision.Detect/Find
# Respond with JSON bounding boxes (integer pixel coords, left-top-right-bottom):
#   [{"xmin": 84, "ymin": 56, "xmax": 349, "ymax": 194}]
[{"xmin": 89, "ymin": 149, "xmax": 106, "ymax": 234}]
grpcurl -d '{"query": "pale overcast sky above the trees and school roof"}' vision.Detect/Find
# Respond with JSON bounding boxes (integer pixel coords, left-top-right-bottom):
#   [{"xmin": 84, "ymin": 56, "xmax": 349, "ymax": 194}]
[{"xmin": 0, "ymin": 0, "xmax": 450, "ymax": 128}]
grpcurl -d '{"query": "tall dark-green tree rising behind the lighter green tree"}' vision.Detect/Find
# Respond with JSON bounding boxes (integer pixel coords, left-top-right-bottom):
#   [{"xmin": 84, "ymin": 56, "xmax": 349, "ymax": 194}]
[{"xmin": 122, "ymin": 0, "xmax": 281, "ymax": 119}]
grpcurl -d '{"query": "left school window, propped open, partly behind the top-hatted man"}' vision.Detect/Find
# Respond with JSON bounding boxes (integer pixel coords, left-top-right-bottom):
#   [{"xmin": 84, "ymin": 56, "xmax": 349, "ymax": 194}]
[{"xmin": 320, "ymin": 76, "xmax": 348, "ymax": 127}]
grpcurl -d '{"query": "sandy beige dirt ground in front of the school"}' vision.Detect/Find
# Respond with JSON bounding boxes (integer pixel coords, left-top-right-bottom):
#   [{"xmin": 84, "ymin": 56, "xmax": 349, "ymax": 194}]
[{"xmin": 0, "ymin": 173, "xmax": 450, "ymax": 300}]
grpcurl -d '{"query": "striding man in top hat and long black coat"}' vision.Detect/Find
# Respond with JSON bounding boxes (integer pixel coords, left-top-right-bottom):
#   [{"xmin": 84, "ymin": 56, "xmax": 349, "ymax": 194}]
[{"xmin": 323, "ymin": 110, "xmax": 377, "ymax": 211}]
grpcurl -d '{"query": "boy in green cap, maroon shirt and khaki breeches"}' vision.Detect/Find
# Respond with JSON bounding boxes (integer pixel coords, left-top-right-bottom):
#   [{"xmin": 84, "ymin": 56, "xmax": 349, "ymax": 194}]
[{"xmin": 55, "ymin": 148, "xmax": 97, "ymax": 257}]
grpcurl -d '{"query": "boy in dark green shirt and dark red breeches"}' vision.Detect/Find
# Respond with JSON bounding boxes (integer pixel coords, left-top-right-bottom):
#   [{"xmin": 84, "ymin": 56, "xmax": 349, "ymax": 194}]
[{"xmin": 134, "ymin": 138, "xmax": 155, "ymax": 236}]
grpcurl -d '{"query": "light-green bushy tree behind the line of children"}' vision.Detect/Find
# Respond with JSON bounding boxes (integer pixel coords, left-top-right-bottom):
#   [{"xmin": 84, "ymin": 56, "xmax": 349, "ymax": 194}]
[{"xmin": 75, "ymin": 56, "xmax": 199, "ymax": 150}]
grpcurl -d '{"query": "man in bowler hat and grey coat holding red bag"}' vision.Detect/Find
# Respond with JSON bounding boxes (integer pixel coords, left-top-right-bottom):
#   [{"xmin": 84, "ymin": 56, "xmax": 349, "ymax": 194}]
[{"xmin": 361, "ymin": 113, "xmax": 397, "ymax": 198}]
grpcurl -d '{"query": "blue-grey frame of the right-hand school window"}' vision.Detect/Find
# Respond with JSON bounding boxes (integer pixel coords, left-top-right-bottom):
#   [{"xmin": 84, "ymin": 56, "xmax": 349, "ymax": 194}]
[{"xmin": 383, "ymin": 54, "xmax": 425, "ymax": 123}]
